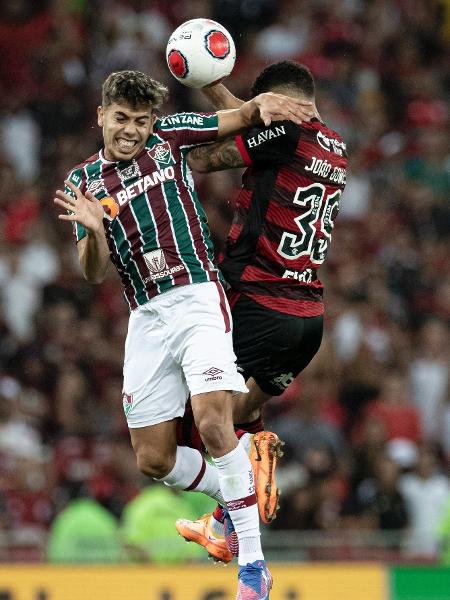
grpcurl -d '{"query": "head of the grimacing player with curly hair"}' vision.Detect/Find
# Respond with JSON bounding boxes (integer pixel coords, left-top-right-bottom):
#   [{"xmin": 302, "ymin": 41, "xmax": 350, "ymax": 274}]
[{"xmin": 97, "ymin": 71, "xmax": 167, "ymax": 160}]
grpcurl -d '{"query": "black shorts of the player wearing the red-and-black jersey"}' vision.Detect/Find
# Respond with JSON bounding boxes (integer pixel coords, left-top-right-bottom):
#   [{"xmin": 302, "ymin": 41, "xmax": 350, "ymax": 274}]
[{"xmin": 231, "ymin": 295, "xmax": 323, "ymax": 396}]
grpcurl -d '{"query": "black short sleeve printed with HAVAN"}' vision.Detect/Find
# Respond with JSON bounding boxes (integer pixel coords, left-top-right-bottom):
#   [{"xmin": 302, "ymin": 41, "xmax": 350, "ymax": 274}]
[{"xmin": 235, "ymin": 121, "xmax": 301, "ymax": 166}]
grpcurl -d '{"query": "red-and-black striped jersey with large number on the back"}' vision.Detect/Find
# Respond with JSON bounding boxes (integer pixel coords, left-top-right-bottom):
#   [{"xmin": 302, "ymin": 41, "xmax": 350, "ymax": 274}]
[{"xmin": 220, "ymin": 119, "xmax": 347, "ymax": 317}]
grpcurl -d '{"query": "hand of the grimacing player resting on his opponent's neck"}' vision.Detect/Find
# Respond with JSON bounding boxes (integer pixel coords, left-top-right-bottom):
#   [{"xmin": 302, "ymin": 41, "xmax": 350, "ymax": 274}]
[{"xmin": 253, "ymin": 92, "xmax": 315, "ymax": 125}]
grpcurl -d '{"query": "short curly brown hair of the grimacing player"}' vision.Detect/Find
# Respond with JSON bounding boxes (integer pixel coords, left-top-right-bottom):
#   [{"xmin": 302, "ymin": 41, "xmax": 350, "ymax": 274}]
[{"xmin": 102, "ymin": 71, "xmax": 168, "ymax": 109}]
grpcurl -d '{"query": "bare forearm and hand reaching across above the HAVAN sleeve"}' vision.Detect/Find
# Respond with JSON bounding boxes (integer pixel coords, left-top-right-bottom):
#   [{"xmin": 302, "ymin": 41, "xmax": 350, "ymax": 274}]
[{"xmin": 217, "ymin": 92, "xmax": 315, "ymax": 138}]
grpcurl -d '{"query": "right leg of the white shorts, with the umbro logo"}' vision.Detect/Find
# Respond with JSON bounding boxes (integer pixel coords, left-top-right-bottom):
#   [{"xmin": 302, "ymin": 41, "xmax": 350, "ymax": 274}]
[{"xmin": 168, "ymin": 282, "xmax": 247, "ymax": 396}]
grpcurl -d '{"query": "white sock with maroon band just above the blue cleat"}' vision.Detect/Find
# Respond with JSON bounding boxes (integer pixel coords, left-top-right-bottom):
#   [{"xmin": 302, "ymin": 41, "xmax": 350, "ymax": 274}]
[{"xmin": 213, "ymin": 444, "xmax": 264, "ymax": 565}]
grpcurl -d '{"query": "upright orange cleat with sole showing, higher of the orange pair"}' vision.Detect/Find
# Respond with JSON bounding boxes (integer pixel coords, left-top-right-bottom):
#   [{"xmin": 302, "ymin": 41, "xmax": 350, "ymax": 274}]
[{"xmin": 250, "ymin": 431, "xmax": 284, "ymax": 523}]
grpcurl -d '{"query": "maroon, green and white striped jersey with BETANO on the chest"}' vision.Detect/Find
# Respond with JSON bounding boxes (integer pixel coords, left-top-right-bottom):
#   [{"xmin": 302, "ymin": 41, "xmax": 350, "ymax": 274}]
[{"xmin": 68, "ymin": 113, "xmax": 219, "ymax": 309}]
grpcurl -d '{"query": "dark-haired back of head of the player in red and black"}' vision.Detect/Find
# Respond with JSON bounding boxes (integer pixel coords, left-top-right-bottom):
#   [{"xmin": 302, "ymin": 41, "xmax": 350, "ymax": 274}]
[{"xmin": 251, "ymin": 60, "xmax": 315, "ymax": 100}]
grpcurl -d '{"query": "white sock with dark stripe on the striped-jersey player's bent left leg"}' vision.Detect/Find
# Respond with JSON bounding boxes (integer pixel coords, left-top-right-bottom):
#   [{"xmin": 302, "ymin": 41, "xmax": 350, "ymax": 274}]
[{"xmin": 156, "ymin": 446, "xmax": 224, "ymax": 504}]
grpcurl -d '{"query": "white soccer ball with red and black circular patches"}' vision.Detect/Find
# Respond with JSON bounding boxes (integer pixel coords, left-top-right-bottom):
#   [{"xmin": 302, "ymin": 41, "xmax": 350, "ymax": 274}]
[{"xmin": 166, "ymin": 19, "xmax": 236, "ymax": 88}]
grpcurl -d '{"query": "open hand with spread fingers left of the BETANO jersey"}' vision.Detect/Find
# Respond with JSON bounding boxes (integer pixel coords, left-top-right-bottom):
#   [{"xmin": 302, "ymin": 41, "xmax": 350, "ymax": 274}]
[{"xmin": 54, "ymin": 180, "xmax": 105, "ymax": 233}]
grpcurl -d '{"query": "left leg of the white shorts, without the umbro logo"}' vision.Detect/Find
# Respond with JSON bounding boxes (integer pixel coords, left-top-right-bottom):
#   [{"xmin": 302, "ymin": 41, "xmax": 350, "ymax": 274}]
[{"xmin": 123, "ymin": 303, "xmax": 189, "ymax": 429}]
